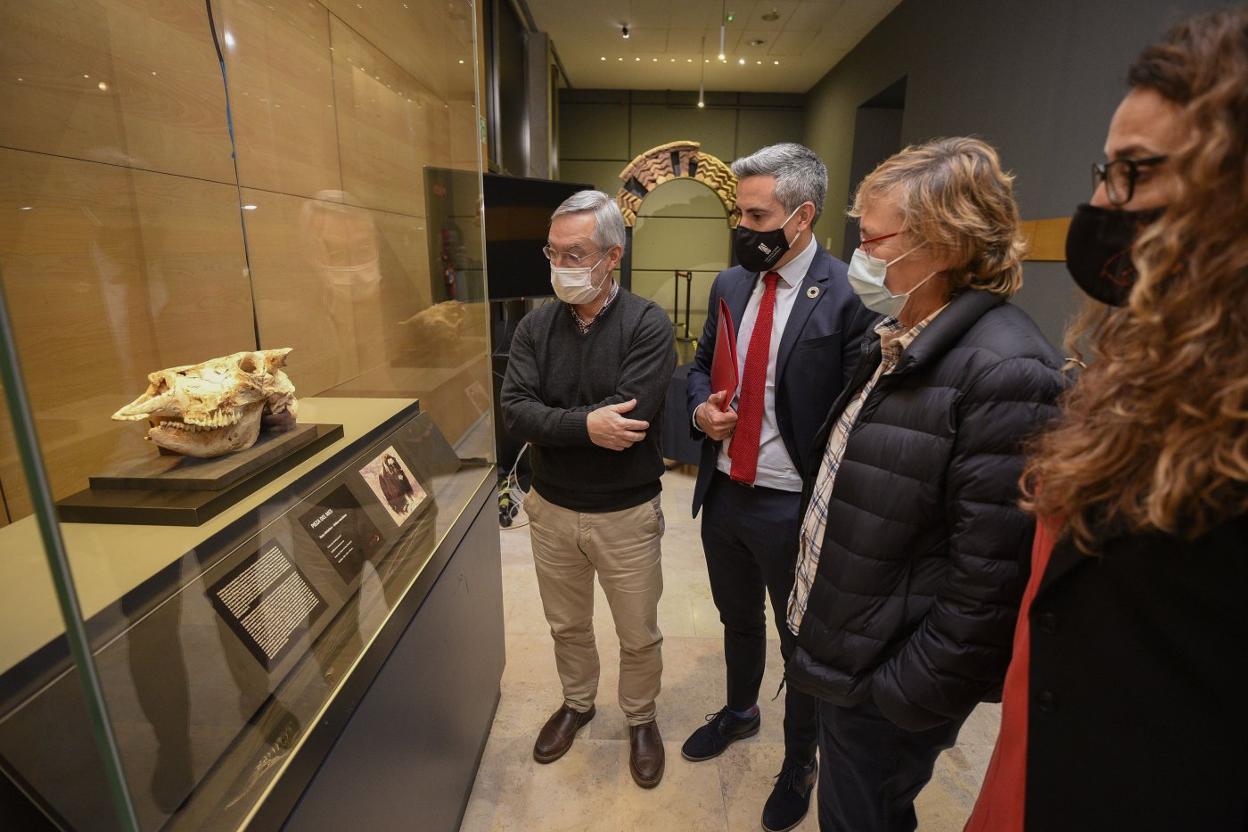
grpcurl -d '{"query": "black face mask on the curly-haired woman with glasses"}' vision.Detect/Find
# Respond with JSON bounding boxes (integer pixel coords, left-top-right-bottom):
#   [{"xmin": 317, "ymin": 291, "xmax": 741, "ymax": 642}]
[{"xmin": 1066, "ymin": 205, "xmax": 1166, "ymax": 306}]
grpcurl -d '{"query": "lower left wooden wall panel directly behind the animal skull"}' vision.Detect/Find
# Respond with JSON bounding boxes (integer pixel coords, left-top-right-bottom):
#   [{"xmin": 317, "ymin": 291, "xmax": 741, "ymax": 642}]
[{"xmin": 0, "ymin": 150, "xmax": 256, "ymax": 518}]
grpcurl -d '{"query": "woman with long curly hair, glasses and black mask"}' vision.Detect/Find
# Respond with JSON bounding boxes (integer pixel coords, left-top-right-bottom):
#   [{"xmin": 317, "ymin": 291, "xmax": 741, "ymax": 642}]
[{"xmin": 967, "ymin": 7, "xmax": 1248, "ymax": 832}]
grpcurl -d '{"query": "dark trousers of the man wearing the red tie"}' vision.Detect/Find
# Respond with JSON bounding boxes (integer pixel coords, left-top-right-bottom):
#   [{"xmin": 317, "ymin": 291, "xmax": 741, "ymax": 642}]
[{"xmin": 701, "ymin": 472, "xmax": 819, "ymax": 763}]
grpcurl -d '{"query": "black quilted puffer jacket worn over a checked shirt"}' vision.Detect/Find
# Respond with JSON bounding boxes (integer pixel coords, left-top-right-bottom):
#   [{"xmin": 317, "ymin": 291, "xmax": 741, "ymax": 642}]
[{"xmin": 787, "ymin": 291, "xmax": 1062, "ymax": 730}]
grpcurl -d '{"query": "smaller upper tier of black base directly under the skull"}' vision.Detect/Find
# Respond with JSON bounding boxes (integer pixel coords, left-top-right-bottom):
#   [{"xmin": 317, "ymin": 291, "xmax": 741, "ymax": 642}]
[{"xmin": 87, "ymin": 424, "xmax": 317, "ymax": 491}]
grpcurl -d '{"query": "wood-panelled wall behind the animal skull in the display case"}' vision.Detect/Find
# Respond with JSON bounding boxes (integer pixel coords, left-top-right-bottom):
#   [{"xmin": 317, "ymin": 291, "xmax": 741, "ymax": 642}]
[{"xmin": 0, "ymin": 0, "xmax": 490, "ymax": 520}]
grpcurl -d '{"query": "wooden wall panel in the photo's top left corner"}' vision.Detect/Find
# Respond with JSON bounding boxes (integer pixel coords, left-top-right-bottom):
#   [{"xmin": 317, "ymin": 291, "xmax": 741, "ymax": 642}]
[{"xmin": 0, "ymin": 0, "xmax": 233, "ymax": 182}]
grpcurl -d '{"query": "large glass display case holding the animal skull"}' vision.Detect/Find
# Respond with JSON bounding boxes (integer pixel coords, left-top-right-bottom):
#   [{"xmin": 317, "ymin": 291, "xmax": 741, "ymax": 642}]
[{"xmin": 0, "ymin": 0, "xmax": 495, "ymax": 830}]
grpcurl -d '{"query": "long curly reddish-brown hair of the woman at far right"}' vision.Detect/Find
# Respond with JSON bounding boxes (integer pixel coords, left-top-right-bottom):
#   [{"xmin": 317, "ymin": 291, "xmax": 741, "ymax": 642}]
[{"xmin": 1022, "ymin": 7, "xmax": 1248, "ymax": 554}]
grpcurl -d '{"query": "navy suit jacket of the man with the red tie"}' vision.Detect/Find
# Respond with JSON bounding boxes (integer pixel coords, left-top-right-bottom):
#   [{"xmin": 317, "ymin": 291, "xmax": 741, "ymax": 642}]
[{"xmin": 686, "ymin": 241, "xmax": 879, "ymax": 516}]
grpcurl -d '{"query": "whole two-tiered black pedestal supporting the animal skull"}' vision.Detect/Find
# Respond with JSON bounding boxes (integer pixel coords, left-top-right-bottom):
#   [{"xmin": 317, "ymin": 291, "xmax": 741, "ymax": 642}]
[{"xmin": 56, "ymin": 424, "xmax": 343, "ymax": 526}]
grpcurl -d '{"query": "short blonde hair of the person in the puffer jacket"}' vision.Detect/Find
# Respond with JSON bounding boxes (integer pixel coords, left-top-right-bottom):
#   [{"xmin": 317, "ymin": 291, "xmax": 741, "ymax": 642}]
[{"xmin": 849, "ymin": 137, "xmax": 1027, "ymax": 298}]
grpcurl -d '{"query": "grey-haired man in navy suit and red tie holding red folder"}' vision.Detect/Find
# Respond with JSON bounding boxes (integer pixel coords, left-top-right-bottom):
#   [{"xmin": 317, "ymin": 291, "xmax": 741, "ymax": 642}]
[{"xmin": 681, "ymin": 143, "xmax": 875, "ymax": 832}]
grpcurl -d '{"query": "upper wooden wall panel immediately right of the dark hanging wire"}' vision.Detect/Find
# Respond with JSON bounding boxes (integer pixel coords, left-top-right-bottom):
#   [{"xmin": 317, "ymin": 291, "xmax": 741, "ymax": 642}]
[{"xmin": 215, "ymin": 0, "xmax": 342, "ymax": 196}]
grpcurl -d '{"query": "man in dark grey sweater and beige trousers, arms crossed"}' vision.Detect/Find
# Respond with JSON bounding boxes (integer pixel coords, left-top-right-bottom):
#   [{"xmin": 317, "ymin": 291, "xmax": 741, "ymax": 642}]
[{"xmin": 500, "ymin": 191, "xmax": 676, "ymax": 788}]
